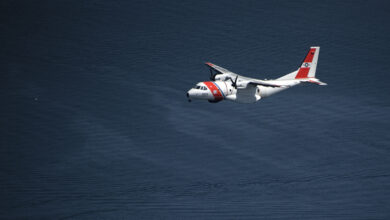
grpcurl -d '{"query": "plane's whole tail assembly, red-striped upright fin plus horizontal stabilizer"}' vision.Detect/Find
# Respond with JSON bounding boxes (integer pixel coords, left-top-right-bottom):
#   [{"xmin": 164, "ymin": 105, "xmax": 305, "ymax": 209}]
[{"xmin": 278, "ymin": 47, "xmax": 326, "ymax": 85}]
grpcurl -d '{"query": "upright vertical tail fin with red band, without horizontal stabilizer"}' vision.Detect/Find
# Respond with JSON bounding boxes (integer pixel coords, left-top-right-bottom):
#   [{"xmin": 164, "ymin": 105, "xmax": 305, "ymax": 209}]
[{"xmin": 295, "ymin": 47, "xmax": 320, "ymax": 79}]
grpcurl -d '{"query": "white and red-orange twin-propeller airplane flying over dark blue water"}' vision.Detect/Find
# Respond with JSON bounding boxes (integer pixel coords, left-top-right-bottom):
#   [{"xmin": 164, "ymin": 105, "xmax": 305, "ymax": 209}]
[{"xmin": 187, "ymin": 46, "xmax": 327, "ymax": 103}]
